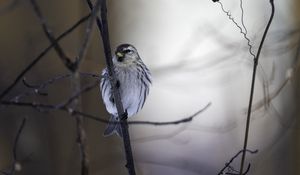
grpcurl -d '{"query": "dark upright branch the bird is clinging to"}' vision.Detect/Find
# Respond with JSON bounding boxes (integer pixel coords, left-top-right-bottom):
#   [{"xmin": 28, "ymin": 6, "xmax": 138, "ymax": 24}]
[{"xmin": 87, "ymin": 0, "xmax": 135, "ymax": 175}]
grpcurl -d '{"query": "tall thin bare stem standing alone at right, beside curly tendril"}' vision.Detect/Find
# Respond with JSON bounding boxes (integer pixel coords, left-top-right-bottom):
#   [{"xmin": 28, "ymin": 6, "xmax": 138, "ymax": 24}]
[{"xmin": 239, "ymin": 0, "xmax": 275, "ymax": 175}]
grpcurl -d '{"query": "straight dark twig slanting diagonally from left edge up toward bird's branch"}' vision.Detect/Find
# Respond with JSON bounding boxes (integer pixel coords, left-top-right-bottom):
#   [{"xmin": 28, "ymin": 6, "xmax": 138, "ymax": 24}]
[{"xmin": 0, "ymin": 14, "xmax": 90, "ymax": 100}]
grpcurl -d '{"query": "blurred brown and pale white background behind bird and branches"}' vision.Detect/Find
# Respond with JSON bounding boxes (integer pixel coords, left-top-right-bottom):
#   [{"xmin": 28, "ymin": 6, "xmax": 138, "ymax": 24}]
[{"xmin": 0, "ymin": 0, "xmax": 300, "ymax": 175}]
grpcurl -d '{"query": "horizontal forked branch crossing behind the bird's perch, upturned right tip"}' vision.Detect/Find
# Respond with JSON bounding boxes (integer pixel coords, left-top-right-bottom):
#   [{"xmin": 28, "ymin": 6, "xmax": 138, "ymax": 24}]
[{"xmin": 0, "ymin": 72, "xmax": 211, "ymax": 126}]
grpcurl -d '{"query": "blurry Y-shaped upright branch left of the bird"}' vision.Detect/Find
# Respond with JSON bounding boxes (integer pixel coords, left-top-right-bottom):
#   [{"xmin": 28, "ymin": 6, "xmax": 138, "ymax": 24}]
[{"xmin": 30, "ymin": 0, "xmax": 100, "ymax": 175}]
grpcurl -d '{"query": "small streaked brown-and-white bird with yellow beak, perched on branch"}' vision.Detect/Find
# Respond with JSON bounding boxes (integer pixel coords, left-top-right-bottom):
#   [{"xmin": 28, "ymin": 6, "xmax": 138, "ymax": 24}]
[{"xmin": 100, "ymin": 44, "xmax": 152, "ymax": 137}]
